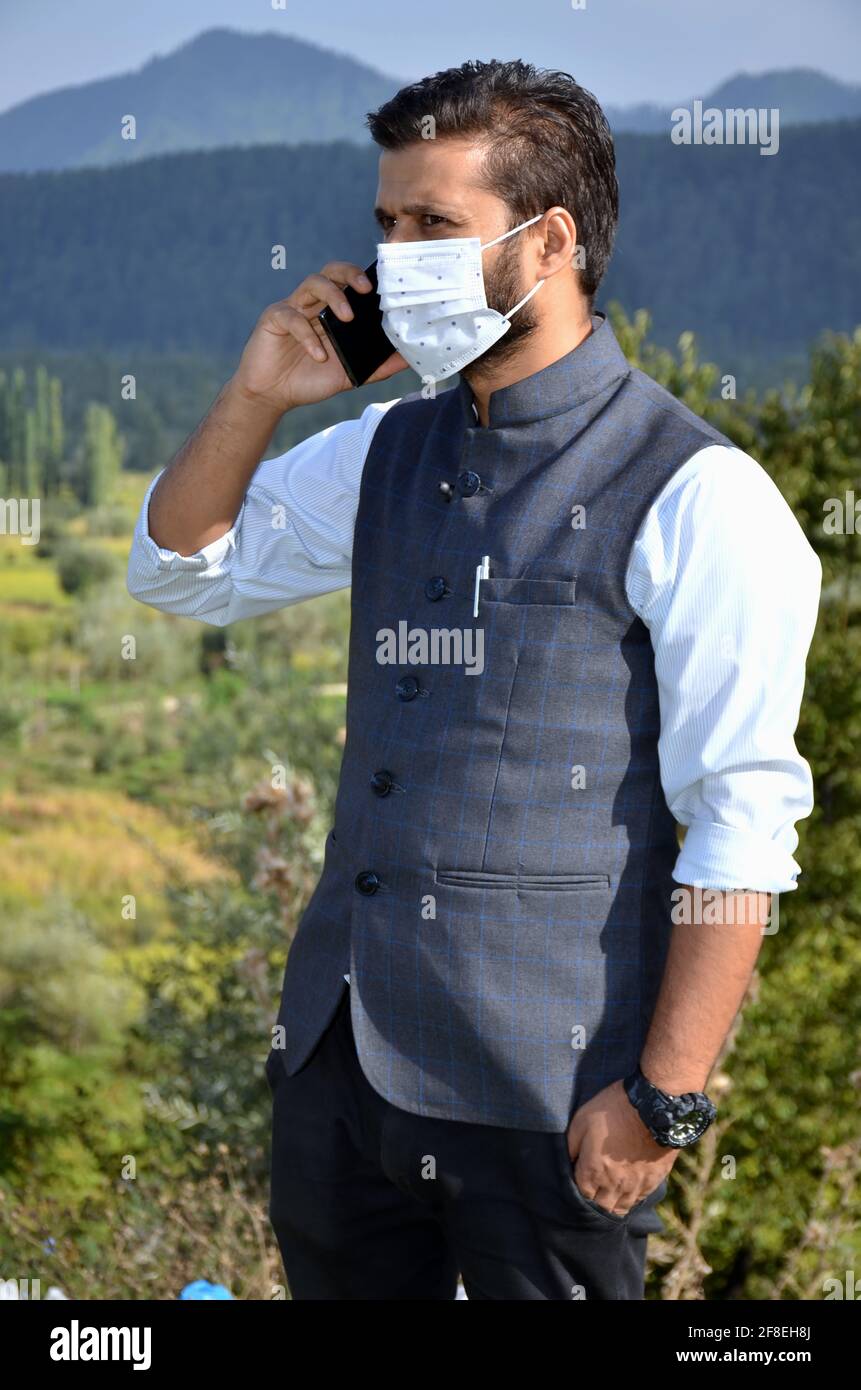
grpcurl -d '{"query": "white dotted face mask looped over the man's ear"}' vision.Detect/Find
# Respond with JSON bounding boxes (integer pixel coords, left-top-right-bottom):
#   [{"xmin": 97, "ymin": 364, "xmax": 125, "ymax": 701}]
[{"xmin": 377, "ymin": 213, "xmax": 544, "ymax": 381}]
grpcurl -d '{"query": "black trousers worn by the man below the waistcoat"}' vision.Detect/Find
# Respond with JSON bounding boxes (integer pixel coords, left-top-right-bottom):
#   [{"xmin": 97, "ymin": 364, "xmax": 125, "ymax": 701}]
[{"xmin": 266, "ymin": 986, "xmax": 666, "ymax": 1301}]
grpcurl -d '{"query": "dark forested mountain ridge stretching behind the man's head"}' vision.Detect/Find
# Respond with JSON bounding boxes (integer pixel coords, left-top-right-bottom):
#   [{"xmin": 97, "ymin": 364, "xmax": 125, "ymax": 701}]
[{"xmin": 0, "ymin": 121, "xmax": 861, "ymax": 369}]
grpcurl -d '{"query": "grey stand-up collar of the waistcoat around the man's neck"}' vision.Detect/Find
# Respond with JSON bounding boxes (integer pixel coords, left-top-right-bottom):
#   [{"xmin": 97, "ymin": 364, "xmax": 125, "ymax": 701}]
[{"xmin": 456, "ymin": 313, "xmax": 630, "ymax": 430}]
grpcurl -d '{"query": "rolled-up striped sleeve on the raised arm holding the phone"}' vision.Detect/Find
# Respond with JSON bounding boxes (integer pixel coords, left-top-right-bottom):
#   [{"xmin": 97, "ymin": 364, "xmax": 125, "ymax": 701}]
[{"xmin": 127, "ymin": 400, "xmax": 396, "ymax": 627}]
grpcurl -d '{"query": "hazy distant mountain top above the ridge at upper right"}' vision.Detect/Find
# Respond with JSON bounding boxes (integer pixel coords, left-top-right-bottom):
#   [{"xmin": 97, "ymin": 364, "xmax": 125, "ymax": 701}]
[{"xmin": 605, "ymin": 68, "xmax": 861, "ymax": 135}]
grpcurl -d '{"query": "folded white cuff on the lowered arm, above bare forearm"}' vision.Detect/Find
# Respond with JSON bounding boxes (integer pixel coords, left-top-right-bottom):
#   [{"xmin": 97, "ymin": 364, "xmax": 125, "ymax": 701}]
[{"xmin": 673, "ymin": 821, "xmax": 801, "ymax": 892}]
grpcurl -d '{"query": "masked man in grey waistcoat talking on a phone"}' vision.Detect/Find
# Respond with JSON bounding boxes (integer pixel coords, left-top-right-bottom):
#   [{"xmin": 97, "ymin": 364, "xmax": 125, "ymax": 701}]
[{"xmin": 129, "ymin": 63, "xmax": 821, "ymax": 1300}]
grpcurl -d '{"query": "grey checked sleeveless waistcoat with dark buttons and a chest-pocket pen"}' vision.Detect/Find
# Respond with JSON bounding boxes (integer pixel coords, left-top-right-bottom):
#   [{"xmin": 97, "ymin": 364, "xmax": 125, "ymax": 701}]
[{"xmin": 272, "ymin": 316, "xmax": 729, "ymax": 1130}]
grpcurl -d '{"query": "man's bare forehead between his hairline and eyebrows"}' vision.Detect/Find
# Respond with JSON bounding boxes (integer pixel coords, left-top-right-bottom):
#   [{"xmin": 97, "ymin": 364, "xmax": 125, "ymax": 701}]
[{"xmin": 377, "ymin": 139, "xmax": 498, "ymax": 213}]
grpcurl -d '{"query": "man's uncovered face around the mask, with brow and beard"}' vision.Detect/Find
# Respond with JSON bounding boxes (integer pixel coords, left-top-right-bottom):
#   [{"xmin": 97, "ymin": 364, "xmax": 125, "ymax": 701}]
[{"xmin": 376, "ymin": 139, "xmax": 538, "ymax": 379}]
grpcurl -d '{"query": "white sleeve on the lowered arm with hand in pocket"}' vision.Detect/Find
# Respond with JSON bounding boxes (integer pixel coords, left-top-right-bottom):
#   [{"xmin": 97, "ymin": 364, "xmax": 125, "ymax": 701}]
[{"xmin": 627, "ymin": 445, "xmax": 822, "ymax": 892}]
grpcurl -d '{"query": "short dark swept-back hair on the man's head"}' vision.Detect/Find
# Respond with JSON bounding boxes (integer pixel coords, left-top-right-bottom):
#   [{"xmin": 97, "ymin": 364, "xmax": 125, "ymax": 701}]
[{"xmin": 367, "ymin": 60, "xmax": 619, "ymax": 306}]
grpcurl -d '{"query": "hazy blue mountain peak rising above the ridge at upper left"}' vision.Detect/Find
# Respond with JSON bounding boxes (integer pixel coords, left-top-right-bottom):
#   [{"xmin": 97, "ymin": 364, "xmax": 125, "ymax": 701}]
[{"xmin": 0, "ymin": 29, "xmax": 401, "ymax": 172}]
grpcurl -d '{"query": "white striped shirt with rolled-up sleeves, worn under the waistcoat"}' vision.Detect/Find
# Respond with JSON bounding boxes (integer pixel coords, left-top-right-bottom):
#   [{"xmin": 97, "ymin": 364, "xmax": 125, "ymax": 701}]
[{"xmin": 128, "ymin": 400, "xmax": 822, "ymax": 892}]
